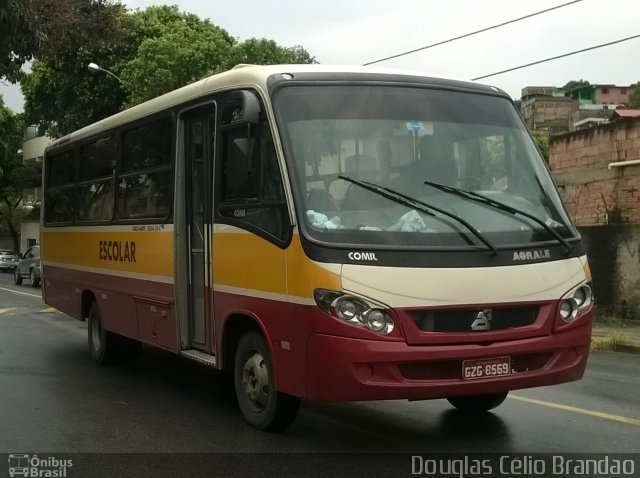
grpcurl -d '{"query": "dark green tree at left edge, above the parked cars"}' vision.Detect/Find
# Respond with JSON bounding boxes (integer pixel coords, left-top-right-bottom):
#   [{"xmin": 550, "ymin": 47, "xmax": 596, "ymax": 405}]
[{"xmin": 0, "ymin": 97, "xmax": 40, "ymax": 251}]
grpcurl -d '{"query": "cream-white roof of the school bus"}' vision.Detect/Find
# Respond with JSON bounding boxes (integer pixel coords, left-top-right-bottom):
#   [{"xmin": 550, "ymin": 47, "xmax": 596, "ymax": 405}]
[{"xmin": 47, "ymin": 64, "xmax": 507, "ymax": 150}]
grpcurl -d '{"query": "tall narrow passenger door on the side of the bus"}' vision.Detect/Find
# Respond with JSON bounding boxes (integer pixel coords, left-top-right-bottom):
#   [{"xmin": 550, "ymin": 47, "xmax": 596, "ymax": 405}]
[{"xmin": 181, "ymin": 105, "xmax": 215, "ymax": 354}]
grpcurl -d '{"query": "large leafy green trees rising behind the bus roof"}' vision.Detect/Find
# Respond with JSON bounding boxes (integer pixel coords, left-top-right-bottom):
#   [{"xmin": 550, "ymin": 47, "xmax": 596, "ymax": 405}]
[{"xmin": 21, "ymin": 0, "xmax": 315, "ymax": 137}]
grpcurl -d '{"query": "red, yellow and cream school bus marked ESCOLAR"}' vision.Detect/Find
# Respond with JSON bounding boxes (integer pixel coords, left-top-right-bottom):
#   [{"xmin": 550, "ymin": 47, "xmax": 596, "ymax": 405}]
[{"xmin": 41, "ymin": 65, "xmax": 593, "ymax": 430}]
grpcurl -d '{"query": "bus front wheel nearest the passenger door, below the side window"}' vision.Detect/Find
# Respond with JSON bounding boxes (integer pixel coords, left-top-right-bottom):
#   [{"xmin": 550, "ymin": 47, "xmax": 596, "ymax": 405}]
[{"xmin": 233, "ymin": 330, "xmax": 300, "ymax": 432}]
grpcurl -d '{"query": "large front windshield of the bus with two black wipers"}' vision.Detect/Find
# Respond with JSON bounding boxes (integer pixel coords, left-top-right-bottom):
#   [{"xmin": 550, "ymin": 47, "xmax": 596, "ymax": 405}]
[{"xmin": 274, "ymin": 84, "xmax": 577, "ymax": 249}]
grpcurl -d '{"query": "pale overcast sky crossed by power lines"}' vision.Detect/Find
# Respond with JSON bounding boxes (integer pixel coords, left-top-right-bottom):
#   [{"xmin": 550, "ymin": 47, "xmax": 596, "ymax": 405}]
[{"xmin": 0, "ymin": 0, "xmax": 640, "ymax": 112}]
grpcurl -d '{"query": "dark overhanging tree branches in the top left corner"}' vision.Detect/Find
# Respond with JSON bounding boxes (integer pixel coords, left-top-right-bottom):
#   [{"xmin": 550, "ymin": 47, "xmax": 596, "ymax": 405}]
[{"xmin": 0, "ymin": 0, "xmax": 122, "ymax": 83}]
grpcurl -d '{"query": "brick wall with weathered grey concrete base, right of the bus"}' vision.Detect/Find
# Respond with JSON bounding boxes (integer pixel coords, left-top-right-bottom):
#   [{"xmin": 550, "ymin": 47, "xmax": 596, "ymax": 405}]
[{"xmin": 549, "ymin": 119, "xmax": 640, "ymax": 319}]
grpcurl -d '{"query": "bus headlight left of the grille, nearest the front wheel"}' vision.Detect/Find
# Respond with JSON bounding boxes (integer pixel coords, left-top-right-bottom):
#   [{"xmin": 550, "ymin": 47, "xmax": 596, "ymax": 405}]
[{"xmin": 313, "ymin": 289, "xmax": 394, "ymax": 334}]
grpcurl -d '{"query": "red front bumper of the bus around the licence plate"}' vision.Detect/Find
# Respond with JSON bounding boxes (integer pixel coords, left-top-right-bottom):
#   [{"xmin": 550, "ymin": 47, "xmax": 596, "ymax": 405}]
[{"xmin": 307, "ymin": 323, "xmax": 591, "ymax": 401}]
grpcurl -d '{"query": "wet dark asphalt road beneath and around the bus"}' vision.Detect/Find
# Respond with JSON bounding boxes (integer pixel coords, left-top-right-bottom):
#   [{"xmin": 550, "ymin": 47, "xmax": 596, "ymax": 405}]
[{"xmin": 0, "ymin": 273, "xmax": 640, "ymax": 476}]
